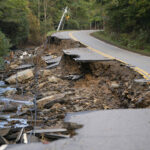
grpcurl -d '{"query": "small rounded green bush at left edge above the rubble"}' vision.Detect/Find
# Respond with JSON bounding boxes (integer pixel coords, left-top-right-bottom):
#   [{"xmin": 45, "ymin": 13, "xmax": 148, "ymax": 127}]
[{"xmin": 0, "ymin": 31, "xmax": 11, "ymax": 57}]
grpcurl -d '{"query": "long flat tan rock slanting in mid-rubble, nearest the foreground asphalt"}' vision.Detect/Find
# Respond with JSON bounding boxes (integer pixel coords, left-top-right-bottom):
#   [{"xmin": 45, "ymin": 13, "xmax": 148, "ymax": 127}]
[{"xmin": 37, "ymin": 94, "xmax": 65, "ymax": 108}]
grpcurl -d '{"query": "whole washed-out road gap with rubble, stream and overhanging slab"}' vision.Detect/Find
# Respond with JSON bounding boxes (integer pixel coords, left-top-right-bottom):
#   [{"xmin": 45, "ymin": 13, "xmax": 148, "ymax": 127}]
[{"xmin": 0, "ymin": 37, "xmax": 150, "ymax": 148}]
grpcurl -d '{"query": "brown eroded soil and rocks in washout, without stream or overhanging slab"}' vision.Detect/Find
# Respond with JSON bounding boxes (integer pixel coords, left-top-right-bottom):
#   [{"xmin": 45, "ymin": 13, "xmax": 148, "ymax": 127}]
[{"xmin": 0, "ymin": 35, "xmax": 150, "ymax": 143}]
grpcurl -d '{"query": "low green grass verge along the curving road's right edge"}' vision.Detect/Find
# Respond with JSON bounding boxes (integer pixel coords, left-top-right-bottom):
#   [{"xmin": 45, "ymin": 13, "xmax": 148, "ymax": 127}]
[{"xmin": 91, "ymin": 31, "xmax": 150, "ymax": 56}]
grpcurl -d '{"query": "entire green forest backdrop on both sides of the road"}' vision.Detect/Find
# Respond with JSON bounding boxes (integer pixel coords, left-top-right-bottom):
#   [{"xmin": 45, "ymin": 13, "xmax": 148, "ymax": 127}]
[{"xmin": 0, "ymin": 0, "xmax": 150, "ymax": 60}]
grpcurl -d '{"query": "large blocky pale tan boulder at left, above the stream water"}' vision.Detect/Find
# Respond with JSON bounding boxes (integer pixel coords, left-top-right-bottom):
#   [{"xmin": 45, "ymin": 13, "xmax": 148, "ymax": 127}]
[{"xmin": 5, "ymin": 69, "xmax": 34, "ymax": 84}]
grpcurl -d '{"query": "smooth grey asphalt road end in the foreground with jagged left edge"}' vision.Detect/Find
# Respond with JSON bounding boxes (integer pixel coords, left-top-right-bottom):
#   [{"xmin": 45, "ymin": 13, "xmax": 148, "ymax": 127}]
[{"xmin": 6, "ymin": 109, "xmax": 150, "ymax": 150}]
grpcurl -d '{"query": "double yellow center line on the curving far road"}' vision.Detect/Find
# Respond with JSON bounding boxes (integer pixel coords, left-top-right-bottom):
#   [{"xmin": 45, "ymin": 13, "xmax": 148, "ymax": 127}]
[{"xmin": 69, "ymin": 32, "xmax": 150, "ymax": 80}]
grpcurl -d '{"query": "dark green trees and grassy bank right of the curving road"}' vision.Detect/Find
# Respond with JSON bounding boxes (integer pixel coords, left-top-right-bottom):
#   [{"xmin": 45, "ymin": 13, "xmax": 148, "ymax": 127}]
[{"xmin": 93, "ymin": 0, "xmax": 150, "ymax": 55}]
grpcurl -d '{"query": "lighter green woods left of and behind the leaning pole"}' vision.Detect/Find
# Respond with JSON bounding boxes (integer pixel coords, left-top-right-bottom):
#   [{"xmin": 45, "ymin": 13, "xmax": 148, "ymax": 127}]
[{"xmin": 0, "ymin": 0, "xmax": 99, "ymax": 66}]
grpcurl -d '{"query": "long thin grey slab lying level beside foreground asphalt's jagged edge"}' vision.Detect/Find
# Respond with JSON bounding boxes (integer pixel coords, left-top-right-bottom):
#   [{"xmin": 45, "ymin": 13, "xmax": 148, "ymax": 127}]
[{"xmin": 27, "ymin": 128, "xmax": 67, "ymax": 134}]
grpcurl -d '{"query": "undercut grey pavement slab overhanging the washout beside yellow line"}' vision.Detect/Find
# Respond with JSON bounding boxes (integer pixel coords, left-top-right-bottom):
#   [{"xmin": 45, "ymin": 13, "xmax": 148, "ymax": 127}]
[{"xmin": 63, "ymin": 48, "xmax": 112, "ymax": 62}]
